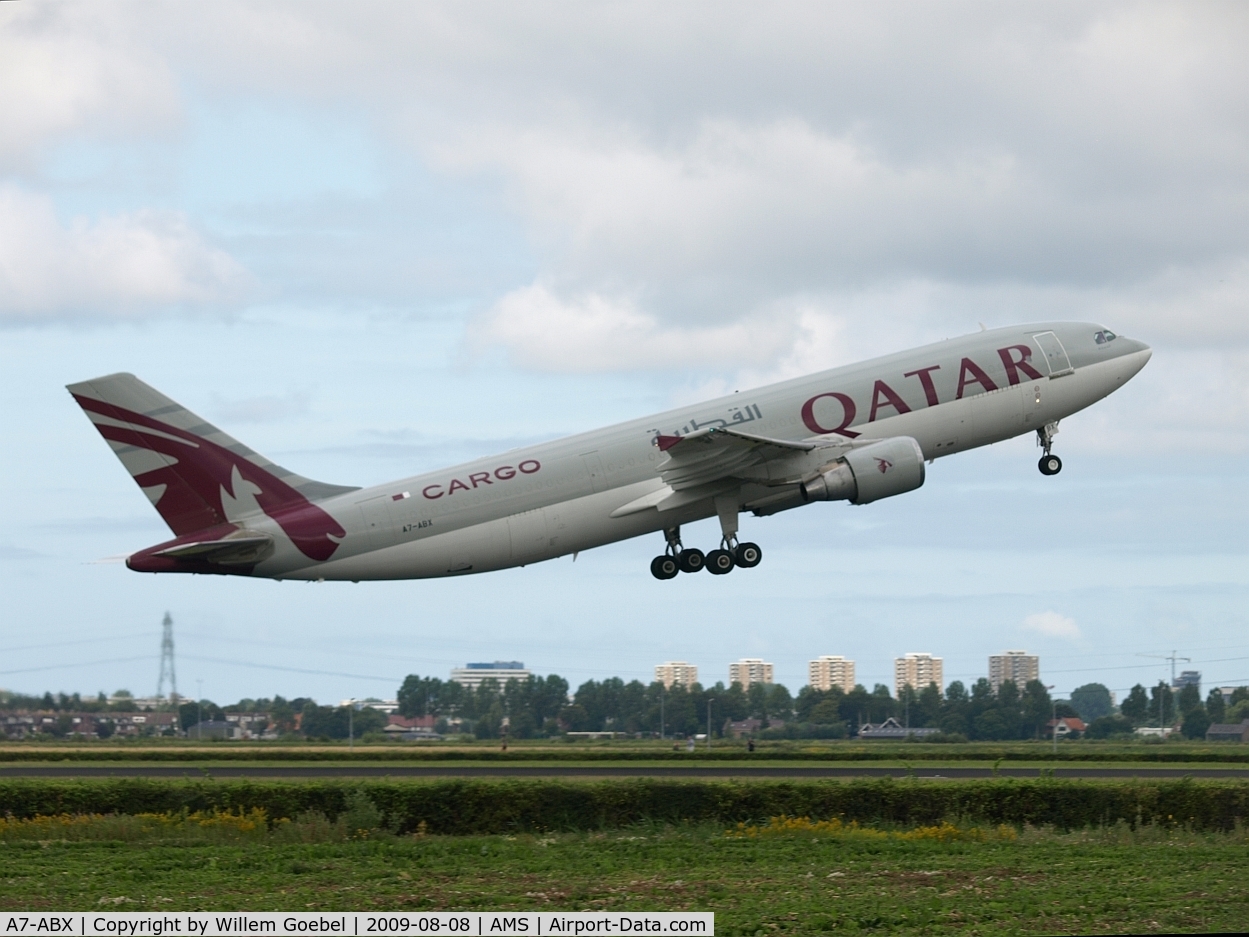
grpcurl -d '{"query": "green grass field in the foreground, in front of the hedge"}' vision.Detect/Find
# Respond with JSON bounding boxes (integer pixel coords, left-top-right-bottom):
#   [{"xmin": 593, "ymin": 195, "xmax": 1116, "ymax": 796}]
[{"xmin": 0, "ymin": 816, "xmax": 1249, "ymax": 935}]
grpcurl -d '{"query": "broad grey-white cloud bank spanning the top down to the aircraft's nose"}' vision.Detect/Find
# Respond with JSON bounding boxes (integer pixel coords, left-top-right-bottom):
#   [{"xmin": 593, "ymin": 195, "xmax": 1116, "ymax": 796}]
[{"xmin": 7, "ymin": 0, "xmax": 1249, "ymax": 367}]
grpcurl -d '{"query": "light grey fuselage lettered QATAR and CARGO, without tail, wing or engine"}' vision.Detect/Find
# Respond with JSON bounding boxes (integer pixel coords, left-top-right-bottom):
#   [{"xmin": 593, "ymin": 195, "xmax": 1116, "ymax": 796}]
[{"xmin": 249, "ymin": 322, "xmax": 1150, "ymax": 580}]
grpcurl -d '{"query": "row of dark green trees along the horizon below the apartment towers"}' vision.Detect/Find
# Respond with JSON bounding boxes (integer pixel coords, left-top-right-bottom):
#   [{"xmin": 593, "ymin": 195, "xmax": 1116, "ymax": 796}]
[{"xmin": 12, "ymin": 673, "xmax": 1249, "ymax": 741}]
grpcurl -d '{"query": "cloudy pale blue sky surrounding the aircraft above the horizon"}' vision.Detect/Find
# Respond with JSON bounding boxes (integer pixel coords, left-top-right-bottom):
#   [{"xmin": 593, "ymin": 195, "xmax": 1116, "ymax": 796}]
[{"xmin": 0, "ymin": 0, "xmax": 1249, "ymax": 702}]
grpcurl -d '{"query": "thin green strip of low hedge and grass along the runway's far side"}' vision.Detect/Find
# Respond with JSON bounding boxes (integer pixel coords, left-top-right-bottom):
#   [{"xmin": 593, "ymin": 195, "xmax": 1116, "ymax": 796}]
[{"xmin": 7, "ymin": 743, "xmax": 1249, "ymax": 765}]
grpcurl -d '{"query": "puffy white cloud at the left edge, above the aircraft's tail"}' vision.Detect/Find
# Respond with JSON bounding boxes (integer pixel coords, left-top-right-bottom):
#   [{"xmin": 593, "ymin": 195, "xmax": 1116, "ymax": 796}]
[{"xmin": 0, "ymin": 186, "xmax": 247, "ymax": 321}]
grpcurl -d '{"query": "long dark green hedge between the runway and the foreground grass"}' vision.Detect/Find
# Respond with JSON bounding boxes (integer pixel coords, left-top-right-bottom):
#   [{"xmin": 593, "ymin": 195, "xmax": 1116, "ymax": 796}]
[{"xmin": 0, "ymin": 778, "xmax": 1249, "ymax": 835}]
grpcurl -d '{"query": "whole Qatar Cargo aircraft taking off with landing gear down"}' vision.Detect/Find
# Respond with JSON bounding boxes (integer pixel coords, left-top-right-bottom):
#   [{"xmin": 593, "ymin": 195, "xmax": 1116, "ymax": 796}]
[{"xmin": 69, "ymin": 322, "xmax": 1150, "ymax": 581}]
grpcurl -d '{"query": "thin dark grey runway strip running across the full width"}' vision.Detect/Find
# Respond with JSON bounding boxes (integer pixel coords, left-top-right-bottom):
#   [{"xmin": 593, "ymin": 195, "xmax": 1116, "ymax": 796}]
[{"xmin": 0, "ymin": 763, "xmax": 1249, "ymax": 781}]
